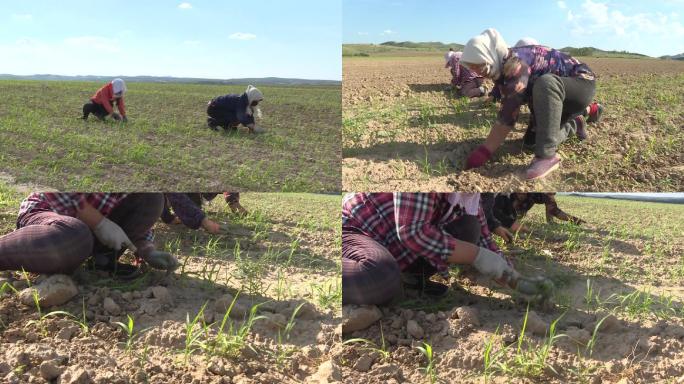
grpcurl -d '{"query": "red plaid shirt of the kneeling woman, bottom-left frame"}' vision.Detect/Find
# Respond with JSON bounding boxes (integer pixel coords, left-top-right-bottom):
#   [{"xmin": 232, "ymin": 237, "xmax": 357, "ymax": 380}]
[{"xmin": 17, "ymin": 193, "xmax": 154, "ymax": 241}]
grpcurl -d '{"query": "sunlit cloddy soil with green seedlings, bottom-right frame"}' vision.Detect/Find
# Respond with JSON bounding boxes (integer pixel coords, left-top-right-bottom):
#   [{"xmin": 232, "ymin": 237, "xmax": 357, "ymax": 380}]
[{"xmin": 340, "ymin": 196, "xmax": 684, "ymax": 383}]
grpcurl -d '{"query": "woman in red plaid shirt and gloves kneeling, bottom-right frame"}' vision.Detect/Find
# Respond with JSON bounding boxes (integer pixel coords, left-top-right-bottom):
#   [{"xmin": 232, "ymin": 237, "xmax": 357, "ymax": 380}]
[{"xmin": 342, "ymin": 193, "xmax": 519, "ymax": 305}]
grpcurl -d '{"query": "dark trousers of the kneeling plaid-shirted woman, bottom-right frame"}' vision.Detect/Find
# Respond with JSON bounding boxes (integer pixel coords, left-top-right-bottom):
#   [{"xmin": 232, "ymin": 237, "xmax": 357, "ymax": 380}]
[{"xmin": 342, "ymin": 216, "xmax": 480, "ymax": 305}]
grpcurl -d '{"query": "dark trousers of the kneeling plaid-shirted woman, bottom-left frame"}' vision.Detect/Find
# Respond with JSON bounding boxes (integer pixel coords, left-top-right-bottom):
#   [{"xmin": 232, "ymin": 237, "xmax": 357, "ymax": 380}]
[{"xmin": 0, "ymin": 193, "xmax": 163, "ymax": 274}]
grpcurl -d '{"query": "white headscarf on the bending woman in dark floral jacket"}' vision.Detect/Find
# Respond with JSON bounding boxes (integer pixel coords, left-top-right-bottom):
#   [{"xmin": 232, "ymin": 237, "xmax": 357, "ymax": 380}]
[{"xmin": 461, "ymin": 28, "xmax": 508, "ymax": 80}]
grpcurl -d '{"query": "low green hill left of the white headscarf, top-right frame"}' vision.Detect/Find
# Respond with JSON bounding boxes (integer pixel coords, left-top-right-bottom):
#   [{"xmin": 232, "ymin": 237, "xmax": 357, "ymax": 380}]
[{"xmin": 342, "ymin": 41, "xmax": 463, "ymax": 57}]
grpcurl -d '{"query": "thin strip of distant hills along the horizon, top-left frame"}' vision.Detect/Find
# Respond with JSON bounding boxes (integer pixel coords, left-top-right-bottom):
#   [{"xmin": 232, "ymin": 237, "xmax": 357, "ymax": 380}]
[{"xmin": 0, "ymin": 74, "xmax": 341, "ymax": 85}]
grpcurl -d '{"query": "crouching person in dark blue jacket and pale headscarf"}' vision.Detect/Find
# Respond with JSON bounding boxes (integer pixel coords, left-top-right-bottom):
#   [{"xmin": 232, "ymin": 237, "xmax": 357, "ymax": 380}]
[{"xmin": 207, "ymin": 85, "xmax": 264, "ymax": 133}]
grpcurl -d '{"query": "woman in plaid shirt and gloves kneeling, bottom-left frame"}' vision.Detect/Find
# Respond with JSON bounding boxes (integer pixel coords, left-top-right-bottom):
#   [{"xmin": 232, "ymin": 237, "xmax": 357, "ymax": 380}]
[{"xmin": 0, "ymin": 193, "xmax": 178, "ymax": 276}]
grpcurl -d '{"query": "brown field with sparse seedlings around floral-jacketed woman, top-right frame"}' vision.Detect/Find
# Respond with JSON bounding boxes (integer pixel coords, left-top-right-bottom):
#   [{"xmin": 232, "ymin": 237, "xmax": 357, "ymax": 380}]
[{"xmin": 342, "ymin": 50, "xmax": 684, "ymax": 192}]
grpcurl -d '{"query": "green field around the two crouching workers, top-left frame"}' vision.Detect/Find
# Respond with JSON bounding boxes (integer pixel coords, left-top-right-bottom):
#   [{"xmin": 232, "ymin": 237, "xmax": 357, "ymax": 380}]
[{"xmin": 0, "ymin": 81, "xmax": 341, "ymax": 192}]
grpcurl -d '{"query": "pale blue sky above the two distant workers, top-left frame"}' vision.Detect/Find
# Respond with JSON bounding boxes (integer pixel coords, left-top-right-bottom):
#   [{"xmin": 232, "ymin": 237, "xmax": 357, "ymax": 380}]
[{"xmin": 0, "ymin": 0, "xmax": 342, "ymax": 80}]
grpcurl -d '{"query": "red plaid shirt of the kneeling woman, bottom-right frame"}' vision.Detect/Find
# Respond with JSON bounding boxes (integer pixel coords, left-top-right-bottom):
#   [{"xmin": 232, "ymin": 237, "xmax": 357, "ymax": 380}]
[{"xmin": 342, "ymin": 193, "xmax": 501, "ymax": 277}]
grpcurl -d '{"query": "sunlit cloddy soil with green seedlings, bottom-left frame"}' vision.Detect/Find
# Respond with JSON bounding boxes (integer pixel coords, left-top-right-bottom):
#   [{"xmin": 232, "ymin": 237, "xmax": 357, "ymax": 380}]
[{"xmin": 0, "ymin": 184, "xmax": 342, "ymax": 383}]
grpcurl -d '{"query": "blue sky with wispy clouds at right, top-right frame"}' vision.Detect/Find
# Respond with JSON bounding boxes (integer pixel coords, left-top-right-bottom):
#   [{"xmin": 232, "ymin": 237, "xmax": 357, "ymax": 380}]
[{"xmin": 342, "ymin": 0, "xmax": 684, "ymax": 56}]
